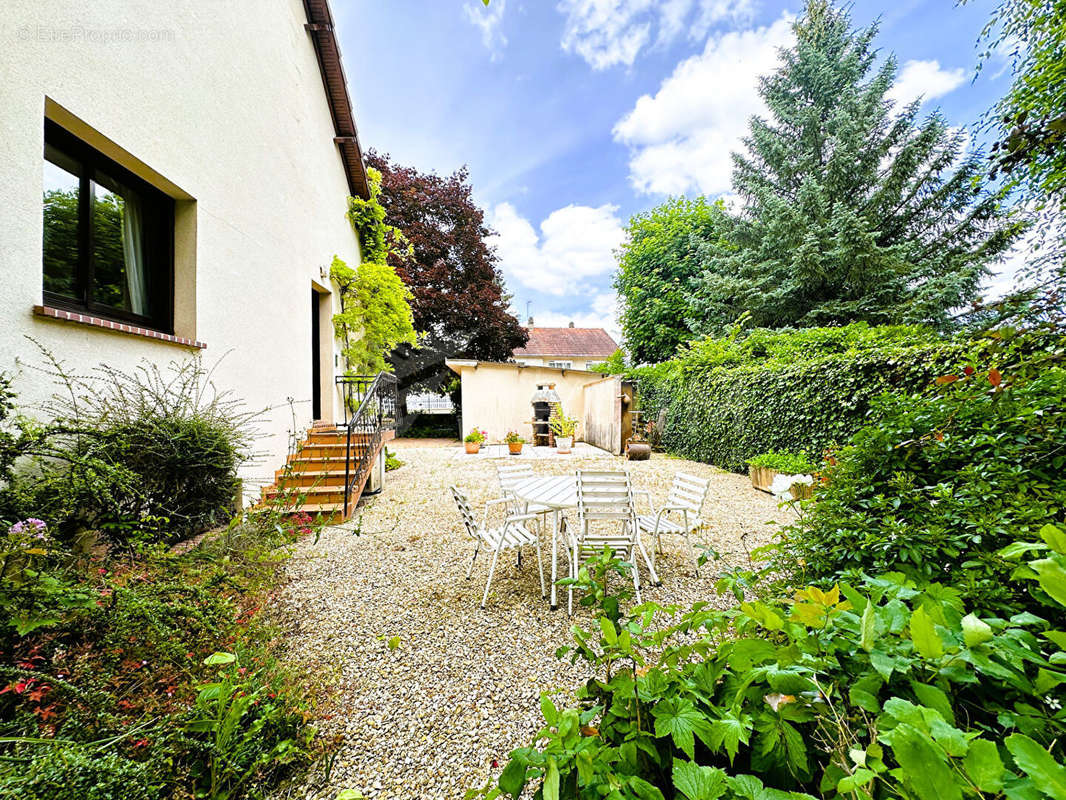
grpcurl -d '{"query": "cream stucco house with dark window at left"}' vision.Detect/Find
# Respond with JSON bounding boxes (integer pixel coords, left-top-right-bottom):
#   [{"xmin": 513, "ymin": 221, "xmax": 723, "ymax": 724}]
[{"xmin": 0, "ymin": 0, "xmax": 385, "ymax": 514}]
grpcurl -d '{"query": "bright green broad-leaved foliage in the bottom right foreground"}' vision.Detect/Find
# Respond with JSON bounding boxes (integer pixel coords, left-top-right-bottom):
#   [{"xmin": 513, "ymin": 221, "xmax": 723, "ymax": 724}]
[{"xmin": 478, "ymin": 546, "xmax": 1066, "ymax": 800}]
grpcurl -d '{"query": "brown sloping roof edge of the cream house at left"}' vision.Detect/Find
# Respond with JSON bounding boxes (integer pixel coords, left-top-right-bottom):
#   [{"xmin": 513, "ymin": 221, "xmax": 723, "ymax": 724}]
[{"xmin": 304, "ymin": 0, "xmax": 370, "ymax": 199}]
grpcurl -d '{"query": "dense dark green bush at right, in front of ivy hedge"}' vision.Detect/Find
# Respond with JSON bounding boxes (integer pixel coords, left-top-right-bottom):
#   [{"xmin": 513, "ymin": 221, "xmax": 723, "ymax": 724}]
[{"xmin": 773, "ymin": 351, "xmax": 1066, "ymax": 614}]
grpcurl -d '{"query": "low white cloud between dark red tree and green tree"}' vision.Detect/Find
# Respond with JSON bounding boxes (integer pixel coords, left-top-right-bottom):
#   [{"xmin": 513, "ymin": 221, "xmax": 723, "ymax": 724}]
[{"xmin": 488, "ymin": 203, "xmax": 624, "ymax": 294}]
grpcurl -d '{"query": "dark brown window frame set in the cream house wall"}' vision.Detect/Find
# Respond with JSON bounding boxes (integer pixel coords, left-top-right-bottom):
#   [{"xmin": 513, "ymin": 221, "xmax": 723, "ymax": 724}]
[{"xmin": 42, "ymin": 119, "xmax": 174, "ymax": 334}]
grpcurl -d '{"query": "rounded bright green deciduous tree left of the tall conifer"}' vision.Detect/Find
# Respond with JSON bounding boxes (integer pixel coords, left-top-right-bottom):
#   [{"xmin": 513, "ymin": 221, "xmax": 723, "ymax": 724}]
[{"xmin": 614, "ymin": 197, "xmax": 725, "ymax": 364}]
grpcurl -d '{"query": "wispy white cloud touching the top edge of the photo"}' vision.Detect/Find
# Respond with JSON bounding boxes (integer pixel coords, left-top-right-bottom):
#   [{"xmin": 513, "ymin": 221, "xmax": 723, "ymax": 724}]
[{"xmin": 559, "ymin": 0, "xmax": 754, "ymax": 69}]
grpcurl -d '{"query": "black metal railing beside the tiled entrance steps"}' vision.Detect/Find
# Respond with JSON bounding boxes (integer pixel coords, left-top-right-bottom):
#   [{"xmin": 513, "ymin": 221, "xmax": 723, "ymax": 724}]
[{"xmin": 337, "ymin": 372, "xmax": 397, "ymax": 518}]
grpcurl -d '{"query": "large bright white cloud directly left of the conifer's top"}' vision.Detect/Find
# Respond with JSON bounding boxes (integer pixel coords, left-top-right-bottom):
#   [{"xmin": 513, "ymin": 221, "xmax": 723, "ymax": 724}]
[{"xmin": 614, "ymin": 14, "xmax": 794, "ymax": 194}]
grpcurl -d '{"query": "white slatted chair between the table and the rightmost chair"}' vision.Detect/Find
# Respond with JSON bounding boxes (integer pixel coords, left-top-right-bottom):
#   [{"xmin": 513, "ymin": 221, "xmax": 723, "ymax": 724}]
[{"xmin": 567, "ymin": 469, "xmax": 659, "ymax": 614}]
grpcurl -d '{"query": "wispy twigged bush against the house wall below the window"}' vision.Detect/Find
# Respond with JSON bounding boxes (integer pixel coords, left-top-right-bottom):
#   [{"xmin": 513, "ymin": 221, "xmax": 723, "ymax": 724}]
[{"xmin": 0, "ymin": 356, "xmax": 258, "ymax": 542}]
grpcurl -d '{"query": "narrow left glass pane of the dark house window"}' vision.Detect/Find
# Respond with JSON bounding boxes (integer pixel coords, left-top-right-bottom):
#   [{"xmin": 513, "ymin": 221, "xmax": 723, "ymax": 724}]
[{"xmin": 44, "ymin": 145, "xmax": 81, "ymax": 298}]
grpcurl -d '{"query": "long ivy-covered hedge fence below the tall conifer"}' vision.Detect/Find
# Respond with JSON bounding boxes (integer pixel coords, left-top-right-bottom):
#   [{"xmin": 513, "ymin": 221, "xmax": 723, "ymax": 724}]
[{"xmin": 629, "ymin": 325, "xmax": 969, "ymax": 471}]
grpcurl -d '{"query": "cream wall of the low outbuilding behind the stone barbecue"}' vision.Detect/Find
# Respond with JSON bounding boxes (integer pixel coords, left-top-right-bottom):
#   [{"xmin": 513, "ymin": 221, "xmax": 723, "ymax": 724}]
[{"xmin": 448, "ymin": 362, "xmax": 603, "ymax": 442}]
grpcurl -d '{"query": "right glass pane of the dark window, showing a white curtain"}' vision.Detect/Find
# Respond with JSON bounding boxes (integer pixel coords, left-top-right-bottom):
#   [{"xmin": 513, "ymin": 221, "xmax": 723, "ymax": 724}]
[{"xmin": 90, "ymin": 172, "xmax": 148, "ymax": 315}]
